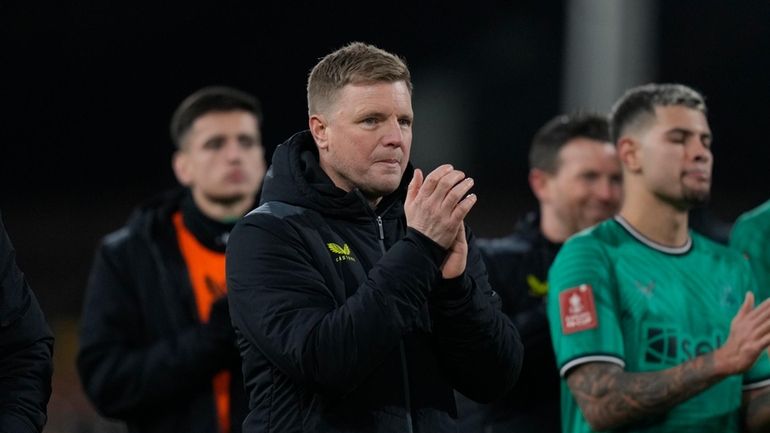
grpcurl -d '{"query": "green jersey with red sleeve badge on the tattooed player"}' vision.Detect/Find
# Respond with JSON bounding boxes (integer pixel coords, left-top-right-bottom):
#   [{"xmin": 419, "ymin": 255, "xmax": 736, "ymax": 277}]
[{"xmin": 548, "ymin": 217, "xmax": 770, "ymax": 433}]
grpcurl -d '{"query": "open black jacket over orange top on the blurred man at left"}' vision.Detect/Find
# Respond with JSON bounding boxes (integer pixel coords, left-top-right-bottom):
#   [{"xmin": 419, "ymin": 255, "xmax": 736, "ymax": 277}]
[{"xmin": 77, "ymin": 190, "xmax": 246, "ymax": 433}]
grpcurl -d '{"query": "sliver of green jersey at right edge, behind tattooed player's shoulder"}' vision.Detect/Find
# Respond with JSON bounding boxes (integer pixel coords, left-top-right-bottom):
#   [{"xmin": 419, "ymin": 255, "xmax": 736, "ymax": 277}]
[{"xmin": 730, "ymin": 201, "xmax": 770, "ymax": 299}]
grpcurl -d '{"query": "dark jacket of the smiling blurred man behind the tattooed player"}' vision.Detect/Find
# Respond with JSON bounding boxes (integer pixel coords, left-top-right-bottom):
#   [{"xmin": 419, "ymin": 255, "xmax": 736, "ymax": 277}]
[{"xmin": 456, "ymin": 212, "xmax": 562, "ymax": 433}]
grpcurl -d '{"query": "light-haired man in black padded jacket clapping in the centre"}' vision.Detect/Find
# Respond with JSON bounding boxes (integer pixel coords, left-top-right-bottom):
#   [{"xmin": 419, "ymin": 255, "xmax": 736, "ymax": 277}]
[{"xmin": 227, "ymin": 43, "xmax": 522, "ymax": 433}]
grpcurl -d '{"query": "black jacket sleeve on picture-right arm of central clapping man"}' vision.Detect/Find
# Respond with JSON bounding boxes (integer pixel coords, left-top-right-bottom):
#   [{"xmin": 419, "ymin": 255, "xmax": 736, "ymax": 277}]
[{"xmin": 429, "ymin": 226, "xmax": 524, "ymax": 403}]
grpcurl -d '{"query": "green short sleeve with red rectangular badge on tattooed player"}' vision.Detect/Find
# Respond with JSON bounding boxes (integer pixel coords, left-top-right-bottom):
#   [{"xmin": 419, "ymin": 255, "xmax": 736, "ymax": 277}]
[{"xmin": 548, "ymin": 235, "xmax": 624, "ymax": 376}]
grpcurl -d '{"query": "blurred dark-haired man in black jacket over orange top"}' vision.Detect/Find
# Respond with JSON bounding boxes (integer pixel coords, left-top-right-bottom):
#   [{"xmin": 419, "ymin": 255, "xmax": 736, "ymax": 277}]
[{"xmin": 77, "ymin": 86, "xmax": 266, "ymax": 433}]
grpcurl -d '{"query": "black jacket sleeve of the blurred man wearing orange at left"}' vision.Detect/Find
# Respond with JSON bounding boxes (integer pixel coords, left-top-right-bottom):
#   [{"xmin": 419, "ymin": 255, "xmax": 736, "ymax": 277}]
[{"xmin": 77, "ymin": 232, "xmax": 237, "ymax": 419}]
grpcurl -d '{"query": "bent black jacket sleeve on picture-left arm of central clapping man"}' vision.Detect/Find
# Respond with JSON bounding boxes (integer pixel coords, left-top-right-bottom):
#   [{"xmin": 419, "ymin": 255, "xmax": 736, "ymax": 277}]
[{"xmin": 226, "ymin": 214, "xmax": 445, "ymax": 395}]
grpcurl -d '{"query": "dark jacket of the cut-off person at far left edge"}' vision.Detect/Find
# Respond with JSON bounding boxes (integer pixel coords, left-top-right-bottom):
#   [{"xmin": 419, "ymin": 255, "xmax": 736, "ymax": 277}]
[{"xmin": 0, "ymin": 212, "xmax": 54, "ymax": 433}]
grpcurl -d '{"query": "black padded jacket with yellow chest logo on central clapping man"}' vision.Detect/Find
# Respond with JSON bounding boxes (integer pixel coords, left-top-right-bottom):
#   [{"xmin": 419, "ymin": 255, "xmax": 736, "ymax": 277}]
[{"xmin": 227, "ymin": 131, "xmax": 522, "ymax": 433}]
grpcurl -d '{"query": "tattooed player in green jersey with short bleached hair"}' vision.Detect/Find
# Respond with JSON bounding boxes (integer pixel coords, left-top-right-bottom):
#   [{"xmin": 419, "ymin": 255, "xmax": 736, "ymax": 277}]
[{"xmin": 547, "ymin": 83, "xmax": 770, "ymax": 433}]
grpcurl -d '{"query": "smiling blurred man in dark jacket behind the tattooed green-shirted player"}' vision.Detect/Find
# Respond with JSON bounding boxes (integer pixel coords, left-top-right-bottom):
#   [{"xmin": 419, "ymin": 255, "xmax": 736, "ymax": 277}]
[{"xmin": 458, "ymin": 112, "xmax": 621, "ymax": 433}]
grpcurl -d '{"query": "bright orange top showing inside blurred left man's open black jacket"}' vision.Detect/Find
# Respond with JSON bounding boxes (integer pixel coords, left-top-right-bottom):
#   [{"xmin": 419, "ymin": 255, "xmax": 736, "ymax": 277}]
[{"xmin": 173, "ymin": 212, "xmax": 230, "ymax": 433}]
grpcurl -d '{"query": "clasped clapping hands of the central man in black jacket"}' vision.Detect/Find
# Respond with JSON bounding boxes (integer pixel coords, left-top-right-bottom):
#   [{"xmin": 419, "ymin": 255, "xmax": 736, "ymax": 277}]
[{"xmin": 404, "ymin": 164, "xmax": 476, "ymax": 279}]
